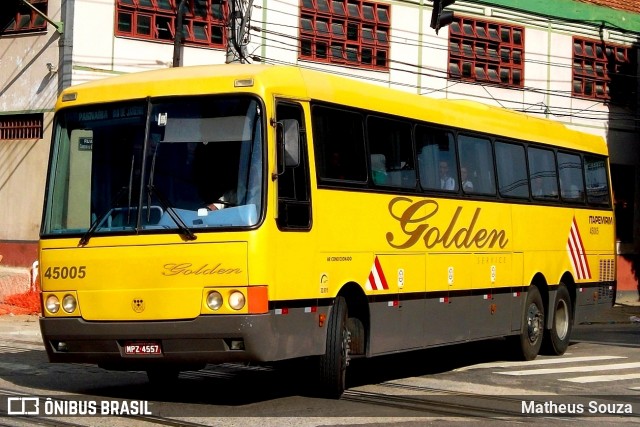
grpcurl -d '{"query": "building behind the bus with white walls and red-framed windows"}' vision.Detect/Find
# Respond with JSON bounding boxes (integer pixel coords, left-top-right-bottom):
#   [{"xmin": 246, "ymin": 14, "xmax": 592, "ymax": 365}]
[{"xmin": 0, "ymin": 0, "xmax": 640, "ymax": 294}]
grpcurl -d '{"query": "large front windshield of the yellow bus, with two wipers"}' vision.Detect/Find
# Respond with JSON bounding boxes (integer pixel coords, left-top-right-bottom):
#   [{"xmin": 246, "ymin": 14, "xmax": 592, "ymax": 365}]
[{"xmin": 42, "ymin": 96, "xmax": 263, "ymax": 239}]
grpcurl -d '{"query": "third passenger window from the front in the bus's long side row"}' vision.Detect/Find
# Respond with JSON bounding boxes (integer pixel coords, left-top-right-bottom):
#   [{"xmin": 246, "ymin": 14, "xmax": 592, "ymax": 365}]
[{"xmin": 415, "ymin": 126, "xmax": 458, "ymax": 191}]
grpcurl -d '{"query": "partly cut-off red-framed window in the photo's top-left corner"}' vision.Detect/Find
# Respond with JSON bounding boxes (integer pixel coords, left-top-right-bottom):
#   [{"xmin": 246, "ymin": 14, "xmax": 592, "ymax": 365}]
[{"xmin": 0, "ymin": 0, "xmax": 49, "ymax": 35}]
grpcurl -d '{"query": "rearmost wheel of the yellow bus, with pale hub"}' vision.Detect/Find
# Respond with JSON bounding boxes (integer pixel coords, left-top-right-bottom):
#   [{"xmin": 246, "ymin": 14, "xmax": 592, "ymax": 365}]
[{"xmin": 542, "ymin": 283, "xmax": 573, "ymax": 356}]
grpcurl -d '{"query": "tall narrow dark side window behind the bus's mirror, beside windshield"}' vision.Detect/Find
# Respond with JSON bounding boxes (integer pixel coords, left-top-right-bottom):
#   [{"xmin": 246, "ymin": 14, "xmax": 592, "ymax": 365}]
[{"xmin": 276, "ymin": 102, "xmax": 311, "ymax": 230}]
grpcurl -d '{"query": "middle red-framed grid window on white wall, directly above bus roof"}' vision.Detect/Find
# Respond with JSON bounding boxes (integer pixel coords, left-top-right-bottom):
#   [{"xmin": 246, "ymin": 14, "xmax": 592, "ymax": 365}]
[{"xmin": 300, "ymin": 0, "xmax": 391, "ymax": 70}]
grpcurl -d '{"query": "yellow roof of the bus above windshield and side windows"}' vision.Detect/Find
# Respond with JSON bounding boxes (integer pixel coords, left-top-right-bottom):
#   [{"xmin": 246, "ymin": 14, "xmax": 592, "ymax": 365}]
[{"xmin": 56, "ymin": 64, "xmax": 607, "ymax": 155}]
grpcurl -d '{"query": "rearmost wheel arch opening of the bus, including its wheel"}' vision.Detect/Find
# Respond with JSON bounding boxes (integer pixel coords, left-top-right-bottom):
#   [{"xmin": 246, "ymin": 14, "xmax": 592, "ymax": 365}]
[{"xmin": 542, "ymin": 274, "xmax": 576, "ymax": 356}]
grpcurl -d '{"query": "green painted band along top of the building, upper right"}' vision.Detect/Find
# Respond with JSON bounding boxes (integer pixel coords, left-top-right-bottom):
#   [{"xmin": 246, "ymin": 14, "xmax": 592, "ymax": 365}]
[{"xmin": 477, "ymin": 0, "xmax": 640, "ymax": 33}]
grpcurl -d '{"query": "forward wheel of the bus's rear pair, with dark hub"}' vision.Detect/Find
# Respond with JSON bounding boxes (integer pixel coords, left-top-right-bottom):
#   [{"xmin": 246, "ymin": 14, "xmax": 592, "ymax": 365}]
[{"xmin": 516, "ymin": 285, "xmax": 544, "ymax": 360}]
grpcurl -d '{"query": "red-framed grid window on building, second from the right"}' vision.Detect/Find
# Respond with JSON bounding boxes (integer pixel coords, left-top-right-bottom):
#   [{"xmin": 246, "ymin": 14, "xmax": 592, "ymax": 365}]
[{"xmin": 448, "ymin": 17, "xmax": 524, "ymax": 87}]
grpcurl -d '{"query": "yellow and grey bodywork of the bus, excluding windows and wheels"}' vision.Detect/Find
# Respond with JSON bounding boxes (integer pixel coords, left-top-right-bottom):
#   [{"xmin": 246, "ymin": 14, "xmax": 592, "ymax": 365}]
[{"xmin": 40, "ymin": 65, "xmax": 615, "ymax": 398}]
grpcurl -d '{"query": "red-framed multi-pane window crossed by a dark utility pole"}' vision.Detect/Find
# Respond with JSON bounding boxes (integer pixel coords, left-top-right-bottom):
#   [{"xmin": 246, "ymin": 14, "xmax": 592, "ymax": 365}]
[{"xmin": 115, "ymin": 0, "xmax": 228, "ymax": 48}]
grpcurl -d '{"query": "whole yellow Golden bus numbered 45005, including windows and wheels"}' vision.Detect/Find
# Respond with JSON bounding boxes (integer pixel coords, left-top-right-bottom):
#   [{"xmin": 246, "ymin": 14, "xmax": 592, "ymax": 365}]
[{"xmin": 39, "ymin": 65, "xmax": 615, "ymax": 397}]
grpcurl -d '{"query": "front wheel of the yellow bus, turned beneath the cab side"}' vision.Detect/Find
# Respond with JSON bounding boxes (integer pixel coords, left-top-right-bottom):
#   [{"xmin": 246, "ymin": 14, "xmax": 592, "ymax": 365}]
[{"xmin": 320, "ymin": 297, "xmax": 350, "ymax": 399}]
